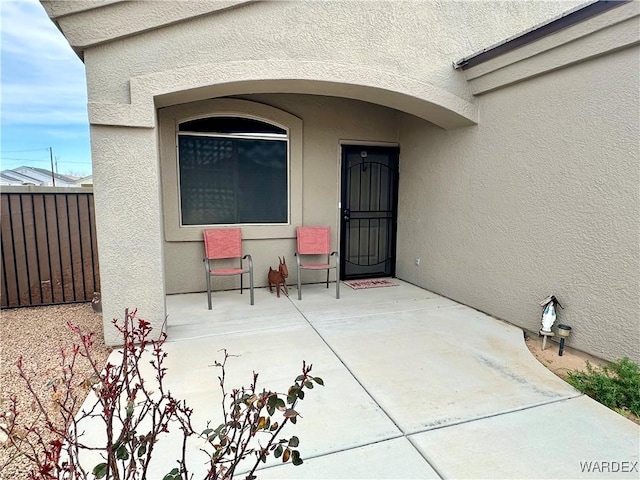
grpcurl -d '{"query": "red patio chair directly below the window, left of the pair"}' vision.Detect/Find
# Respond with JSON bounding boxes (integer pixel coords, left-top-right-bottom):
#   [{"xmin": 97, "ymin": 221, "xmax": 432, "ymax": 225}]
[{"xmin": 203, "ymin": 228, "xmax": 253, "ymax": 310}]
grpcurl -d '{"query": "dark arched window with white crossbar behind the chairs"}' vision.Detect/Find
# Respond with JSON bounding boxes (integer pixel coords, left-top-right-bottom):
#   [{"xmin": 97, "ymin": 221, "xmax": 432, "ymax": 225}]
[{"xmin": 178, "ymin": 116, "xmax": 289, "ymax": 226}]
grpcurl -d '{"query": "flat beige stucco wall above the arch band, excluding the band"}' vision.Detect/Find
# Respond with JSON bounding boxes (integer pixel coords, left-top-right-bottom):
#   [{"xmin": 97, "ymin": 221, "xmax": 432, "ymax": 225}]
[{"xmin": 77, "ymin": 0, "xmax": 583, "ymax": 103}]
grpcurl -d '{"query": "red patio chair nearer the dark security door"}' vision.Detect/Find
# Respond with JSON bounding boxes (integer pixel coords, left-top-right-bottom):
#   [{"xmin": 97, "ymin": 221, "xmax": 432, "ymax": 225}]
[{"xmin": 295, "ymin": 227, "xmax": 340, "ymax": 300}]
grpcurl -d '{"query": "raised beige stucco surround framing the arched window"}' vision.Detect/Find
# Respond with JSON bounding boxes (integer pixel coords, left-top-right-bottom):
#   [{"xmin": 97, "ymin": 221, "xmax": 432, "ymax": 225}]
[{"xmin": 158, "ymin": 98, "xmax": 302, "ymax": 242}]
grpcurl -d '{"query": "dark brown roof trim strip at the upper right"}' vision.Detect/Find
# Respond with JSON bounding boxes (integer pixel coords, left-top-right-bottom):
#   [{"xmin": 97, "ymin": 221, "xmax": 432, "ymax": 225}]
[{"xmin": 453, "ymin": 0, "xmax": 632, "ymax": 70}]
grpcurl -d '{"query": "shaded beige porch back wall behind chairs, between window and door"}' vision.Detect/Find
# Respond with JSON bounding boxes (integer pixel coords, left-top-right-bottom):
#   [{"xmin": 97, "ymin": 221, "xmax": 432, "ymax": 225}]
[{"xmin": 161, "ymin": 94, "xmax": 400, "ymax": 293}]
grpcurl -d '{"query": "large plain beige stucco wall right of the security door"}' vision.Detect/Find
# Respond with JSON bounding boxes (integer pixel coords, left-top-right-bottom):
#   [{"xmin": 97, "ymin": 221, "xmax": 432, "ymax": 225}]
[{"xmin": 398, "ymin": 47, "xmax": 640, "ymax": 361}]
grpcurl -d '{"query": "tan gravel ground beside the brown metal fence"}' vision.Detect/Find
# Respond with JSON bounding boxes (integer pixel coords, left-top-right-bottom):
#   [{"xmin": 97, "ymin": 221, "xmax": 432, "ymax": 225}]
[{"xmin": 0, "ymin": 303, "xmax": 111, "ymax": 480}]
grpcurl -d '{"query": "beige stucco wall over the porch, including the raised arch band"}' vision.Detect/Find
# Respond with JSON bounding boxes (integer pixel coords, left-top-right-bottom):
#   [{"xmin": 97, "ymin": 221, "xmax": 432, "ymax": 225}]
[{"xmin": 70, "ymin": 0, "xmax": 592, "ymax": 128}]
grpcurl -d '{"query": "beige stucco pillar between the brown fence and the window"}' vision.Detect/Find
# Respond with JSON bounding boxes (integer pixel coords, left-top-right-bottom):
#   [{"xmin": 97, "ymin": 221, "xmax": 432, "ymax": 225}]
[{"xmin": 91, "ymin": 126, "xmax": 165, "ymax": 345}]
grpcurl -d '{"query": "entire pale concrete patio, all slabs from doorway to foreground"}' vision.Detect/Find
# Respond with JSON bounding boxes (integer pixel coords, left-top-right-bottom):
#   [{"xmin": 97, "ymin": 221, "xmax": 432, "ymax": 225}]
[{"xmin": 148, "ymin": 280, "xmax": 640, "ymax": 479}]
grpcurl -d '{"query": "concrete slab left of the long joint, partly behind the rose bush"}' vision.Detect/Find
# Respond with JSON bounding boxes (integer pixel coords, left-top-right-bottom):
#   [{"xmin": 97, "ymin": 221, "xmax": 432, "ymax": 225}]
[{"xmin": 162, "ymin": 312, "xmax": 402, "ymax": 476}]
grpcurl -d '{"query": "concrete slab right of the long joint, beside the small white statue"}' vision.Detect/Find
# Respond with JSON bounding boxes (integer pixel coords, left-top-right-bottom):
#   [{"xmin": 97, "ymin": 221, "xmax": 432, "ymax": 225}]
[{"xmin": 313, "ymin": 300, "xmax": 579, "ymax": 433}]
